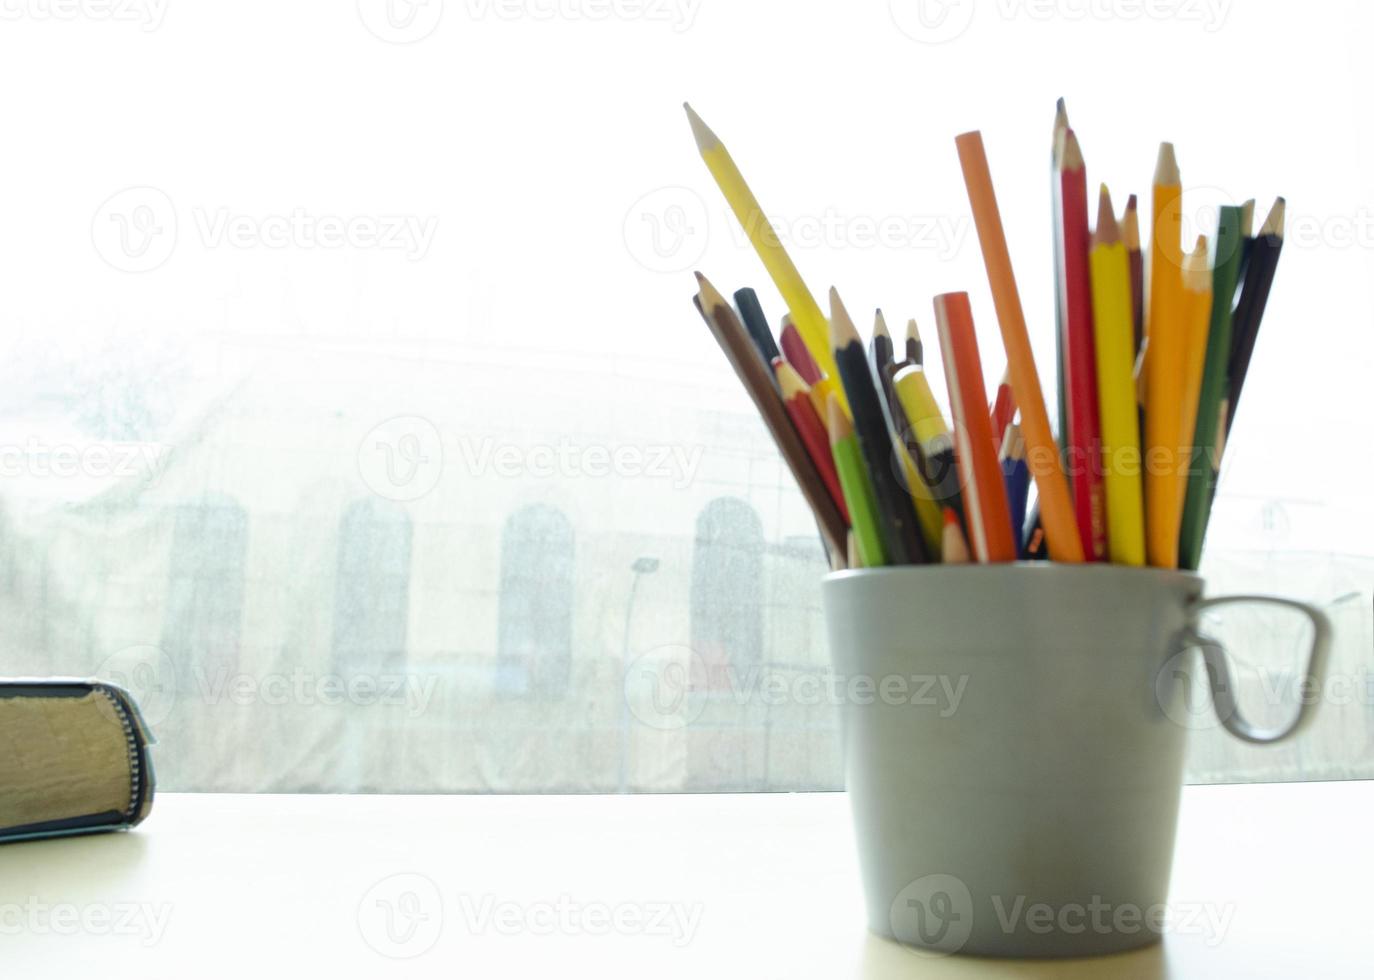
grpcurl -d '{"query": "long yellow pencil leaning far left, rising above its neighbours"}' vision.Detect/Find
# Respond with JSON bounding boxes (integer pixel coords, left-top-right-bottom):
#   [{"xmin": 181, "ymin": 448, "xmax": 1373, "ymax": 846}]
[{"xmin": 683, "ymin": 103, "xmax": 849, "ymax": 412}]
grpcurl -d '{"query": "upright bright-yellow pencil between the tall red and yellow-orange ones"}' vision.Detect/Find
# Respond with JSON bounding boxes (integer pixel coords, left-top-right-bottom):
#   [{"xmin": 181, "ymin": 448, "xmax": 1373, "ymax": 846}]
[{"xmin": 1088, "ymin": 184, "xmax": 1145, "ymax": 565}]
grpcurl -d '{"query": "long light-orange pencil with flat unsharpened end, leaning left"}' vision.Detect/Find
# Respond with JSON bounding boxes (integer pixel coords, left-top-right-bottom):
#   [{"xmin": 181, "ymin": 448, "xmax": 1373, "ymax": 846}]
[{"xmin": 955, "ymin": 132, "xmax": 1083, "ymax": 562}]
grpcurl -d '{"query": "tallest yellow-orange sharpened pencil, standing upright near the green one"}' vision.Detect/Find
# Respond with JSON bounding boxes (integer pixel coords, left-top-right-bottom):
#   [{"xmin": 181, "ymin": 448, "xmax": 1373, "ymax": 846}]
[{"xmin": 1145, "ymin": 143, "xmax": 1183, "ymax": 568}]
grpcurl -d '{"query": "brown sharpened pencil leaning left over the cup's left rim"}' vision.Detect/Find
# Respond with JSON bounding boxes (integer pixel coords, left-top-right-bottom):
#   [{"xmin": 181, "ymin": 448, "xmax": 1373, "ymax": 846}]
[{"xmin": 695, "ymin": 272, "xmax": 846, "ymax": 558}]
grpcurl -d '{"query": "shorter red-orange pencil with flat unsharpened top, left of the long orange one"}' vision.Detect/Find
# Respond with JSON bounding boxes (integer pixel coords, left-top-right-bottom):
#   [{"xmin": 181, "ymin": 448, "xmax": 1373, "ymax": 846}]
[{"xmin": 934, "ymin": 293, "xmax": 1017, "ymax": 562}]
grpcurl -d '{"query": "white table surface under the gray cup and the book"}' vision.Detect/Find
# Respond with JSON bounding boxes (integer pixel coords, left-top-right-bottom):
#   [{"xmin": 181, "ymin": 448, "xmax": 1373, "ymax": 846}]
[{"xmin": 0, "ymin": 782, "xmax": 1374, "ymax": 980}]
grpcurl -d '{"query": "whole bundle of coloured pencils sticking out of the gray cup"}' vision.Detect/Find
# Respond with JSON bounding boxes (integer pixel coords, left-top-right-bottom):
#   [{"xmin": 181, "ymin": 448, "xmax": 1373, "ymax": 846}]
[{"xmin": 687, "ymin": 99, "xmax": 1285, "ymax": 569}]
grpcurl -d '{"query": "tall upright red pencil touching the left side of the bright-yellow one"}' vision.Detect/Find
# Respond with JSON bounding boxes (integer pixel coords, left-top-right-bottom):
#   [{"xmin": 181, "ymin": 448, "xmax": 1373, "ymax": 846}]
[{"xmin": 1055, "ymin": 129, "xmax": 1107, "ymax": 561}]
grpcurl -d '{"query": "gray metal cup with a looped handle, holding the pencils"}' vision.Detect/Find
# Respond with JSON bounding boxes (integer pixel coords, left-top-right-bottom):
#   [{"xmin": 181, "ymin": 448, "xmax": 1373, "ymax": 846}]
[{"xmin": 822, "ymin": 562, "xmax": 1330, "ymax": 957}]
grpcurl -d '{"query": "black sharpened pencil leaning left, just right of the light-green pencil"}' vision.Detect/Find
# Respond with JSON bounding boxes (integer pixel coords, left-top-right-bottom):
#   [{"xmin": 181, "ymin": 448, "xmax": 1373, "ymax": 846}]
[{"xmin": 830, "ymin": 289, "xmax": 926, "ymax": 565}]
